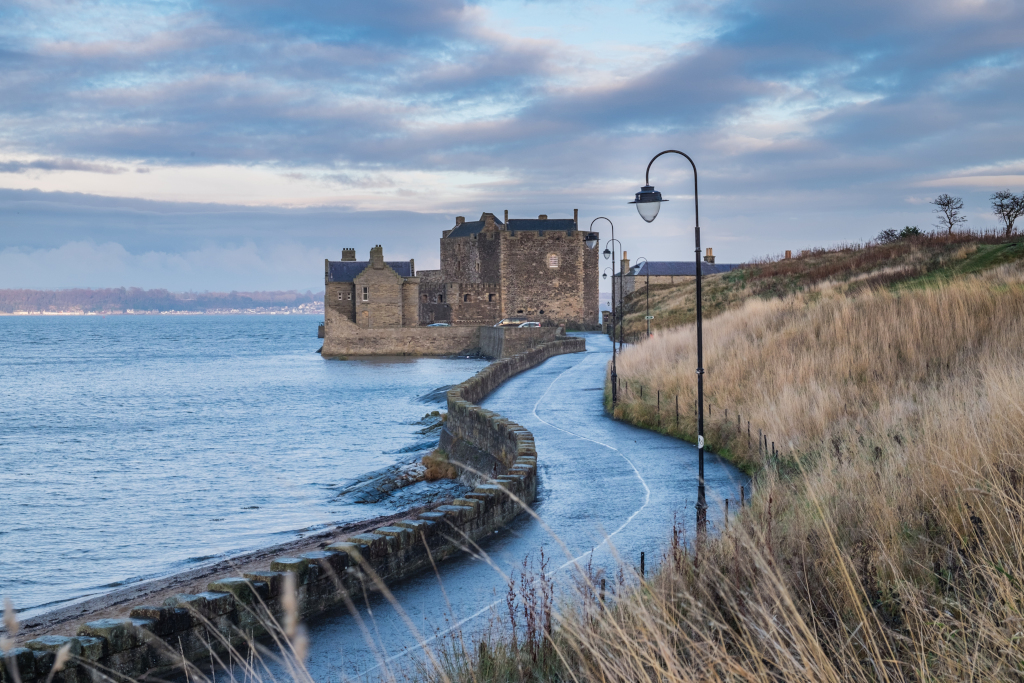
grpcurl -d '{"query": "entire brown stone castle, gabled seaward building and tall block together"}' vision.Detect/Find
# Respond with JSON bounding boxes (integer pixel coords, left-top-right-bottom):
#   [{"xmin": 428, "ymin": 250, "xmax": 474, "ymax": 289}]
[{"xmin": 324, "ymin": 211, "xmax": 599, "ymax": 354}]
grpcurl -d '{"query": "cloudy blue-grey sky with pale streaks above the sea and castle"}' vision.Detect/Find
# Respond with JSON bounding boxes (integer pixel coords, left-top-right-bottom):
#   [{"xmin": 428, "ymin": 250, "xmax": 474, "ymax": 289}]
[{"xmin": 0, "ymin": 0, "xmax": 1024, "ymax": 291}]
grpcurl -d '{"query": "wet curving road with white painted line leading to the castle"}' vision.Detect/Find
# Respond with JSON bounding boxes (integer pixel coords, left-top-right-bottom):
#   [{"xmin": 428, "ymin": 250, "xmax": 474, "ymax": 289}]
[{"xmin": 294, "ymin": 335, "xmax": 748, "ymax": 682}]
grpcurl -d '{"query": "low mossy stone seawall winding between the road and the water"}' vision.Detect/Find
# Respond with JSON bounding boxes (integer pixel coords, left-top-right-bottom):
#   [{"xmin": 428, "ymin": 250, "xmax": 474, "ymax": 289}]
[{"xmin": 0, "ymin": 338, "xmax": 586, "ymax": 683}]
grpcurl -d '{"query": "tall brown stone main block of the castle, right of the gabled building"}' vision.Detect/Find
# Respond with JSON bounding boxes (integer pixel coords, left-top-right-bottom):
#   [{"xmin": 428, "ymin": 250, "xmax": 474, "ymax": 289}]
[{"xmin": 420, "ymin": 211, "xmax": 600, "ymax": 329}]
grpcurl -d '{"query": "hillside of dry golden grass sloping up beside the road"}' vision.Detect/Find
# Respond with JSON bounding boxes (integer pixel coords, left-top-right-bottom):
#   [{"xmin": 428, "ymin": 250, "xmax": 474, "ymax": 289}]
[{"xmin": 428, "ymin": 232, "xmax": 1024, "ymax": 683}]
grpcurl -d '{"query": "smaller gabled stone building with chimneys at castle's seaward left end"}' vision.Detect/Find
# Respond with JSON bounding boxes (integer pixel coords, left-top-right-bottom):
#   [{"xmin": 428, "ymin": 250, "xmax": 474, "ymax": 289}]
[{"xmin": 324, "ymin": 245, "xmax": 420, "ymax": 335}]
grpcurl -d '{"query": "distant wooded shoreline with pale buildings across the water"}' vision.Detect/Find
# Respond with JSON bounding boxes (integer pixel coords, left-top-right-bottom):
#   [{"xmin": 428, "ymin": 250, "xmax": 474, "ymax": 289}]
[{"xmin": 0, "ymin": 287, "xmax": 324, "ymax": 313}]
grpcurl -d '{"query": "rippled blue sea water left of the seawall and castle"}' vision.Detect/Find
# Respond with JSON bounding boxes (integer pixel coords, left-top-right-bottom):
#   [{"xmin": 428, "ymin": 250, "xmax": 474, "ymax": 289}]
[{"xmin": 0, "ymin": 315, "xmax": 485, "ymax": 614}]
